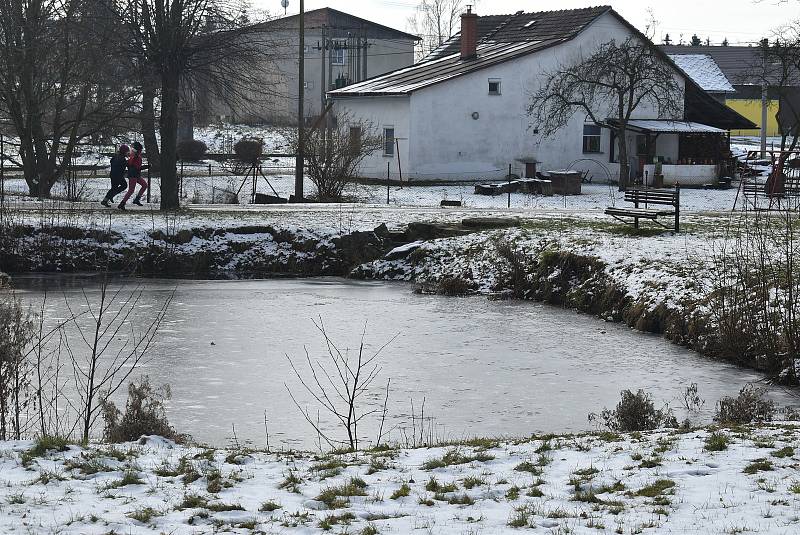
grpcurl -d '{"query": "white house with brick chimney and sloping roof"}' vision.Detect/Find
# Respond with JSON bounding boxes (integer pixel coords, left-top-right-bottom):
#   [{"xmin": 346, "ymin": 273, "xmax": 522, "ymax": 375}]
[{"xmin": 328, "ymin": 6, "xmax": 751, "ymax": 183}]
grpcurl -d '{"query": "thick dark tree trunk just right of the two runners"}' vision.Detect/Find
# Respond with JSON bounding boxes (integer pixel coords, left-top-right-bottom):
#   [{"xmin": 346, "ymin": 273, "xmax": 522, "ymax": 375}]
[{"xmin": 160, "ymin": 72, "xmax": 180, "ymax": 210}]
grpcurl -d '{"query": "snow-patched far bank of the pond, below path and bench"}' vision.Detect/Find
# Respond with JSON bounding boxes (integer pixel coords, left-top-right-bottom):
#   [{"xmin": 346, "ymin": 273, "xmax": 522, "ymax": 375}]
[{"xmin": 0, "ymin": 214, "xmax": 783, "ymax": 382}]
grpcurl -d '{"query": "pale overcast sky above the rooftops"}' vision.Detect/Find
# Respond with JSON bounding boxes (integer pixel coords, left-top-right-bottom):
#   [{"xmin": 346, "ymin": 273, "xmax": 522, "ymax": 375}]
[{"xmin": 252, "ymin": 0, "xmax": 800, "ymax": 44}]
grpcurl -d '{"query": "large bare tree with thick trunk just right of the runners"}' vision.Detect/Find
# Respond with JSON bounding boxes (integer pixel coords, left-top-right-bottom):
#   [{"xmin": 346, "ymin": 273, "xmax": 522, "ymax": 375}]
[{"xmin": 123, "ymin": 0, "xmax": 280, "ymax": 209}]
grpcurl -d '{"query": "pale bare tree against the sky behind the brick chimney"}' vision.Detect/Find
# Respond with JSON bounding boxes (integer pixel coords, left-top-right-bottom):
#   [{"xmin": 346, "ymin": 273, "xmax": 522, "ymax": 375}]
[{"xmin": 408, "ymin": 0, "xmax": 478, "ymax": 59}]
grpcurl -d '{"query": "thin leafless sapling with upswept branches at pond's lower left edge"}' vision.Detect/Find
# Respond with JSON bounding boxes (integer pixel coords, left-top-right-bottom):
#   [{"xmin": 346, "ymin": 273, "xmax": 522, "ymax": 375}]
[{"xmin": 65, "ymin": 277, "xmax": 174, "ymax": 442}]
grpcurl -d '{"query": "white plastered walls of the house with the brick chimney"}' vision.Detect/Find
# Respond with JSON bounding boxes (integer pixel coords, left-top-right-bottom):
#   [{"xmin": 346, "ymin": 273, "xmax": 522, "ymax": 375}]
[{"xmin": 335, "ymin": 14, "xmax": 684, "ymax": 180}]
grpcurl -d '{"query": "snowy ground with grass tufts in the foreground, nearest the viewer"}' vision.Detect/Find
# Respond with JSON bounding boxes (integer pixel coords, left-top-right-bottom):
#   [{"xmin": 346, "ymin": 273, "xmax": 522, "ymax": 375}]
[{"xmin": 9, "ymin": 424, "xmax": 800, "ymax": 535}]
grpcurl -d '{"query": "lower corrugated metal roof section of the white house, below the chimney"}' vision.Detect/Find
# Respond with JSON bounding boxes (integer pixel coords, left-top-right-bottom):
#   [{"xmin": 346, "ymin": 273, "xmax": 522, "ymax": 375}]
[{"xmin": 329, "ymin": 40, "xmax": 561, "ymax": 98}]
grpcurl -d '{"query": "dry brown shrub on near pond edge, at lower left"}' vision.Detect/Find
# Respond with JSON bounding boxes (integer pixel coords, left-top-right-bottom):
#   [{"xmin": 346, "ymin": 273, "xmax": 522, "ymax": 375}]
[{"xmin": 102, "ymin": 375, "xmax": 180, "ymax": 443}]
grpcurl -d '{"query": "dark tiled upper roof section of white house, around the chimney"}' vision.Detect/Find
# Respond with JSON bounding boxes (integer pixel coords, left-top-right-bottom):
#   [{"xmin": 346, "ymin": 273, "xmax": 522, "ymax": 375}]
[{"xmin": 426, "ymin": 6, "xmax": 611, "ymax": 59}]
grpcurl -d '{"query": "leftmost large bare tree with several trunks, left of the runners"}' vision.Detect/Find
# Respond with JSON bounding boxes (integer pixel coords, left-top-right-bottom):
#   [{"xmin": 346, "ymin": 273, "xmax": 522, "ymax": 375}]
[{"xmin": 0, "ymin": 0, "xmax": 134, "ymax": 197}]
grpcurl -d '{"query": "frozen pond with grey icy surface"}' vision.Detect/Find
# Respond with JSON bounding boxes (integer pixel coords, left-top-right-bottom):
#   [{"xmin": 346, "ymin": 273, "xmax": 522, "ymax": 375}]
[{"xmin": 9, "ymin": 277, "xmax": 792, "ymax": 448}]
